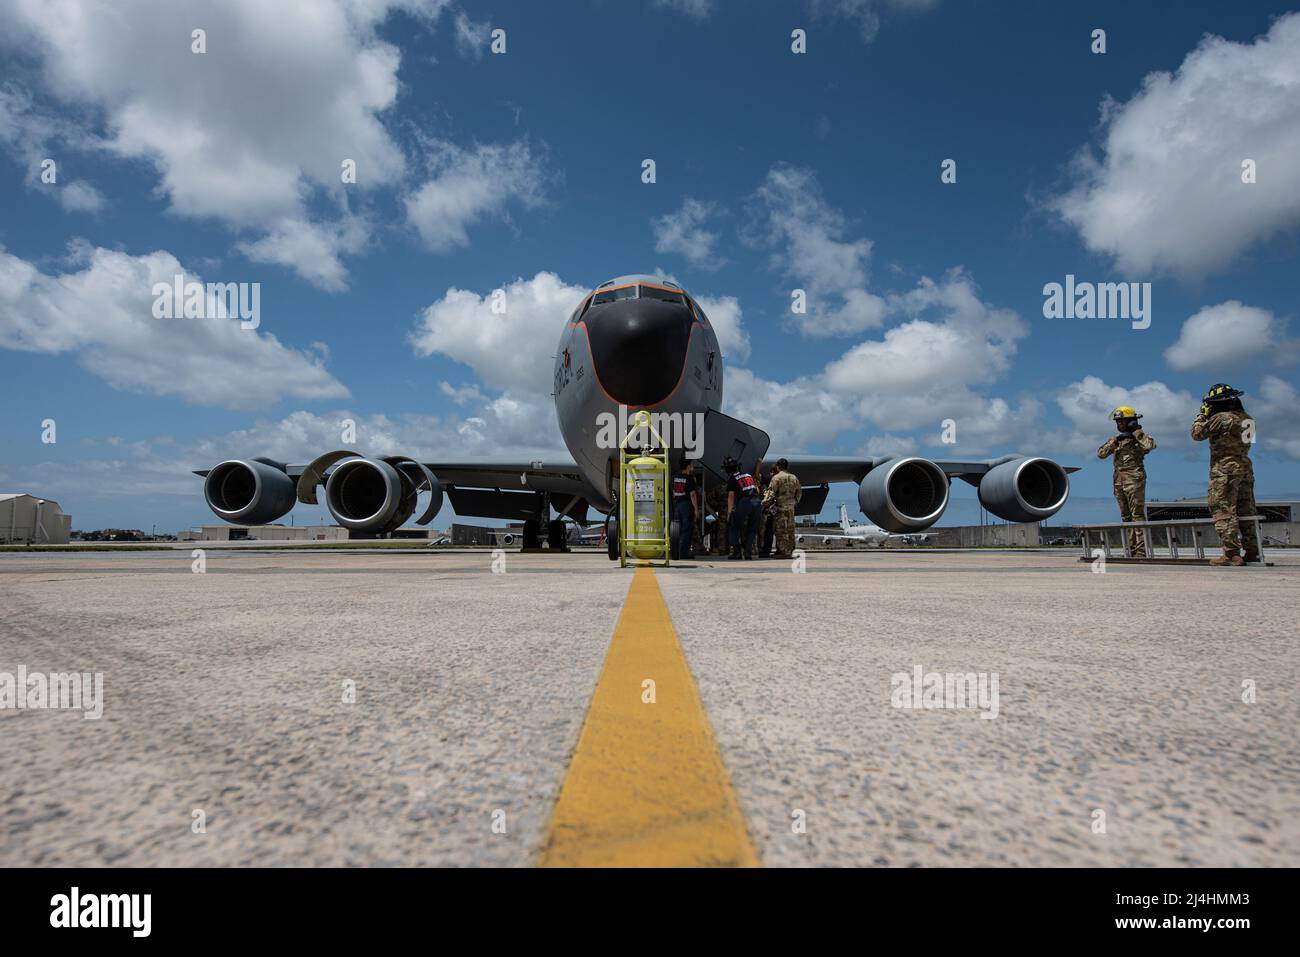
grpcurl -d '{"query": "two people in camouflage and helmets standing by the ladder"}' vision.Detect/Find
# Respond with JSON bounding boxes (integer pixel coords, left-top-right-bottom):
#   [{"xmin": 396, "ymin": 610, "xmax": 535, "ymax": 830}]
[{"xmin": 1097, "ymin": 382, "xmax": 1260, "ymax": 566}]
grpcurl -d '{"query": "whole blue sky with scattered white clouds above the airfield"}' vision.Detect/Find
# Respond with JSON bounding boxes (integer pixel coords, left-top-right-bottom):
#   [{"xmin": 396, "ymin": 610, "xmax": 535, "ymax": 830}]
[{"xmin": 0, "ymin": 0, "xmax": 1300, "ymax": 531}]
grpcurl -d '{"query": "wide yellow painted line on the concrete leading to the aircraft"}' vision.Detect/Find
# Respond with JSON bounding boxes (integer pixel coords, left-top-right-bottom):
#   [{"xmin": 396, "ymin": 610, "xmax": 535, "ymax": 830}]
[{"xmin": 540, "ymin": 568, "xmax": 758, "ymax": 867}]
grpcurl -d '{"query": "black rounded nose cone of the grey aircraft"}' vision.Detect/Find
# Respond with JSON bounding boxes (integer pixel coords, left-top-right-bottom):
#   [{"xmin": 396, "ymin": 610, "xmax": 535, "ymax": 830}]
[{"xmin": 584, "ymin": 299, "xmax": 693, "ymax": 406}]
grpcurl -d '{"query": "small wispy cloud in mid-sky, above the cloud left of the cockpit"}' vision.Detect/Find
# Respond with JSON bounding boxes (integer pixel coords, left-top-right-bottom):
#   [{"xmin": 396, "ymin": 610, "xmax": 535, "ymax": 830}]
[{"xmin": 406, "ymin": 140, "xmax": 543, "ymax": 252}]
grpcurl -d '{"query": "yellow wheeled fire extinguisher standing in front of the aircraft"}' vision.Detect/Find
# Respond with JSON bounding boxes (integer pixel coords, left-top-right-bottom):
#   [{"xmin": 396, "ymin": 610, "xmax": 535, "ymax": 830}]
[{"xmin": 619, "ymin": 410, "xmax": 672, "ymax": 568}]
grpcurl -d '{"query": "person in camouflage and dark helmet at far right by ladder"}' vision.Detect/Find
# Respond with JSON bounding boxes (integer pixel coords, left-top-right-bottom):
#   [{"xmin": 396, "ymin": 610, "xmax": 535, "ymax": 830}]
[{"xmin": 1192, "ymin": 382, "xmax": 1260, "ymax": 566}]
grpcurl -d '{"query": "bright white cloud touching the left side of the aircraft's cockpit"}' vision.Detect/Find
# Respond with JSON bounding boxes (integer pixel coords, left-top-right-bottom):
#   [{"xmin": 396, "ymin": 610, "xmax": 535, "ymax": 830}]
[{"xmin": 411, "ymin": 272, "xmax": 590, "ymax": 399}]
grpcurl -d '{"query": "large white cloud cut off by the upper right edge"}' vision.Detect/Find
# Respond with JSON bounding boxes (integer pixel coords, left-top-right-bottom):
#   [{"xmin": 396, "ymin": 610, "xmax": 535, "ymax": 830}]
[{"xmin": 1050, "ymin": 13, "xmax": 1300, "ymax": 276}]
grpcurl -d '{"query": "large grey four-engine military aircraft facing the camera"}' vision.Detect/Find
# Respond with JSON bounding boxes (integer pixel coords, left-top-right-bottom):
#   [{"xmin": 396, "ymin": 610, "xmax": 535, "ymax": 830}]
[{"xmin": 196, "ymin": 276, "xmax": 1076, "ymax": 557}]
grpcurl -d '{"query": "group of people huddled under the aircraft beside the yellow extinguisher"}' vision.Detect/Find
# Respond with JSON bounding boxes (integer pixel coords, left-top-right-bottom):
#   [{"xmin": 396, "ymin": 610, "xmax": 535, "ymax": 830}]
[{"xmin": 672, "ymin": 456, "xmax": 803, "ymax": 560}]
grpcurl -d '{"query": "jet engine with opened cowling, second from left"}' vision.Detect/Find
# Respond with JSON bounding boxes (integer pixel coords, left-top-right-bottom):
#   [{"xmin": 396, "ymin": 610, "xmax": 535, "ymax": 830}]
[{"xmin": 325, "ymin": 455, "xmax": 442, "ymax": 534}]
